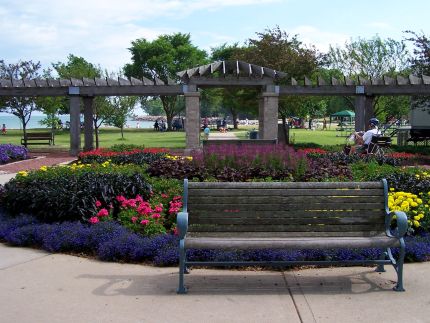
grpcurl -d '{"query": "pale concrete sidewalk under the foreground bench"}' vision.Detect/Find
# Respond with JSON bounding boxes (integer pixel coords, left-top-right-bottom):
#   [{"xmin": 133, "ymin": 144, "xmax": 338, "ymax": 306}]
[{"xmin": 0, "ymin": 244, "xmax": 430, "ymax": 323}]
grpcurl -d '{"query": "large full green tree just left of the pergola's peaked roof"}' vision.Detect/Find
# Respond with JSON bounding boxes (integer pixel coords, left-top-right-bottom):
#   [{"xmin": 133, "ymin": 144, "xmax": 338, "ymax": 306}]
[{"xmin": 124, "ymin": 33, "xmax": 206, "ymax": 130}]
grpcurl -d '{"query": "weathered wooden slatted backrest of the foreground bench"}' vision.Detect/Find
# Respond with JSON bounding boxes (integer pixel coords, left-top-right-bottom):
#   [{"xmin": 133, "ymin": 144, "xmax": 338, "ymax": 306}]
[{"xmin": 185, "ymin": 180, "xmax": 387, "ymax": 237}]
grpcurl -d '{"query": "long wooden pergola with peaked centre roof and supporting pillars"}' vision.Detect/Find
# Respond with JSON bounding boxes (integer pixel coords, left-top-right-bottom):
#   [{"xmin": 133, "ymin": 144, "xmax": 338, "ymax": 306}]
[{"xmin": 0, "ymin": 61, "xmax": 430, "ymax": 155}]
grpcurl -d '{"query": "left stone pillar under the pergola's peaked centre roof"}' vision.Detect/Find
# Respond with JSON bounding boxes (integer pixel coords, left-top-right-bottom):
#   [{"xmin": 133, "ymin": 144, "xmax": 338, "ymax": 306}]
[{"xmin": 184, "ymin": 90, "xmax": 200, "ymax": 153}]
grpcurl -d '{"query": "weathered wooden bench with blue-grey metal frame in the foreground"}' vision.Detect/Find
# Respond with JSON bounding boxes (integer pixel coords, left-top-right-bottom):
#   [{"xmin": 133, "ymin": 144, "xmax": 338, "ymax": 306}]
[{"xmin": 177, "ymin": 179, "xmax": 408, "ymax": 294}]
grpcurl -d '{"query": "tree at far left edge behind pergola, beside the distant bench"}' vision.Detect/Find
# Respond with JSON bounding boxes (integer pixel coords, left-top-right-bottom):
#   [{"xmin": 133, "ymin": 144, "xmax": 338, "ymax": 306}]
[{"xmin": 0, "ymin": 60, "xmax": 41, "ymax": 136}]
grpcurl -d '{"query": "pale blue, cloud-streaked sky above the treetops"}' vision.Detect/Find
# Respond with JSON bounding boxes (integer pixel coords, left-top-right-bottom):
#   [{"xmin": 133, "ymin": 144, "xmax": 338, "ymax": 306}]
[{"xmin": 0, "ymin": 0, "xmax": 430, "ymax": 71}]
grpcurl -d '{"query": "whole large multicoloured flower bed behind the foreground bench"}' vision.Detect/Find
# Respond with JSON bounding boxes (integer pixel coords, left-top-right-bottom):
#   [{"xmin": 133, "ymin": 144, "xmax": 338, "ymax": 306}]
[{"xmin": 0, "ymin": 145, "xmax": 430, "ymax": 265}]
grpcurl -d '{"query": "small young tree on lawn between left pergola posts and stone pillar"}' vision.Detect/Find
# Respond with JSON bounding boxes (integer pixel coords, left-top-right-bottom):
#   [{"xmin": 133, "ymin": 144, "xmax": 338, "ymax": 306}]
[{"xmin": 106, "ymin": 96, "xmax": 138, "ymax": 140}]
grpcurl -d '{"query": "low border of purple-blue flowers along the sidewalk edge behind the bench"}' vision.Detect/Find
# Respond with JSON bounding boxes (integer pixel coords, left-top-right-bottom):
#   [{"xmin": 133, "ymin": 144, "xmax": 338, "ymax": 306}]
[{"xmin": 0, "ymin": 212, "xmax": 430, "ymax": 266}]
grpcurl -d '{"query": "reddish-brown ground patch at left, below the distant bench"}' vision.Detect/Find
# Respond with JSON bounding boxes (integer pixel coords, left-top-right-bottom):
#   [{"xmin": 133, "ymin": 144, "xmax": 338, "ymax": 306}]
[{"xmin": 0, "ymin": 152, "xmax": 76, "ymax": 174}]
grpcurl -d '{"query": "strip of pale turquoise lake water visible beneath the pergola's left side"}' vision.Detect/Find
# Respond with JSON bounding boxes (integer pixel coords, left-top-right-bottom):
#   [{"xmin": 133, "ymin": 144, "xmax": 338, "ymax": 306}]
[{"xmin": 0, "ymin": 113, "xmax": 154, "ymax": 129}]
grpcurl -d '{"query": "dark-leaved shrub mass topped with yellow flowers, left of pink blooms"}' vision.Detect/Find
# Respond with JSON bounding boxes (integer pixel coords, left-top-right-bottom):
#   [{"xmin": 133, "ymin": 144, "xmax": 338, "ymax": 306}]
[{"xmin": 2, "ymin": 163, "xmax": 150, "ymax": 222}]
